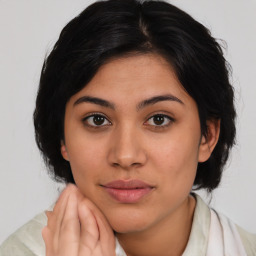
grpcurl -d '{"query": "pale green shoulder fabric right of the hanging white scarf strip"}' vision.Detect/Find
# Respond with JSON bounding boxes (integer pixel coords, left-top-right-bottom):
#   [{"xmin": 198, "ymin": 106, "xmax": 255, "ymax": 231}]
[{"xmin": 236, "ymin": 225, "xmax": 256, "ymax": 256}]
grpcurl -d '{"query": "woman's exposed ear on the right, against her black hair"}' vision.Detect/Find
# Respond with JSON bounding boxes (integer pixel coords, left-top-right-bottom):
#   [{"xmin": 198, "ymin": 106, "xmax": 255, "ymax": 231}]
[{"xmin": 198, "ymin": 119, "xmax": 220, "ymax": 162}]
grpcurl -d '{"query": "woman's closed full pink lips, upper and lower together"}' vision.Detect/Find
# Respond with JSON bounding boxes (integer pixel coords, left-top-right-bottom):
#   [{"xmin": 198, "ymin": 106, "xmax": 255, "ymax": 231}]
[{"xmin": 103, "ymin": 180, "xmax": 154, "ymax": 203}]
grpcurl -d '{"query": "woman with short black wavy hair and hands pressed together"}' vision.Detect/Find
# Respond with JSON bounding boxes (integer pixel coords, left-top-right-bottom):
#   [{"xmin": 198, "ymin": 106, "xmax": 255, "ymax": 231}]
[{"xmin": 1, "ymin": 0, "xmax": 256, "ymax": 256}]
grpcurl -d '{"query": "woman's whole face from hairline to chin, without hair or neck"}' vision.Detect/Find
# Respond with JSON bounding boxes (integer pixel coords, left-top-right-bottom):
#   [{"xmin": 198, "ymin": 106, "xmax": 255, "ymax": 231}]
[{"xmin": 61, "ymin": 54, "xmax": 209, "ymax": 233}]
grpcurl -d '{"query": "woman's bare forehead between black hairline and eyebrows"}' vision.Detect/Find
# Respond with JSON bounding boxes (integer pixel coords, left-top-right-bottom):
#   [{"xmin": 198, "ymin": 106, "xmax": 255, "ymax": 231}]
[{"xmin": 72, "ymin": 54, "xmax": 190, "ymax": 105}]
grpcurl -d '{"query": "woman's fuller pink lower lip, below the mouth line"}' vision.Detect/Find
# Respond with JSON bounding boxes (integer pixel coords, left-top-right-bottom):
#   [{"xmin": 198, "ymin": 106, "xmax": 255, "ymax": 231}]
[{"xmin": 104, "ymin": 187, "xmax": 152, "ymax": 203}]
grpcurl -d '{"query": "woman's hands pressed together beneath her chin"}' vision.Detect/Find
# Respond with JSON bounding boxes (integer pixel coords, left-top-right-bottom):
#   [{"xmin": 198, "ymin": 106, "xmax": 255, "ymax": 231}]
[{"xmin": 42, "ymin": 185, "xmax": 115, "ymax": 256}]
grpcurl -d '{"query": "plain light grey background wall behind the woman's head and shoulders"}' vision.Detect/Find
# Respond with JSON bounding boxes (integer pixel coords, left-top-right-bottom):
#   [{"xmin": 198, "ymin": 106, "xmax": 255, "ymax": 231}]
[{"xmin": 0, "ymin": 0, "xmax": 256, "ymax": 243}]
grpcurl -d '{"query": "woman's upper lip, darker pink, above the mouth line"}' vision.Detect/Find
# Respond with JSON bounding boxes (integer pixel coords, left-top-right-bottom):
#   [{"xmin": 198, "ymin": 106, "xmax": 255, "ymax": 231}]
[{"xmin": 103, "ymin": 180, "xmax": 153, "ymax": 189}]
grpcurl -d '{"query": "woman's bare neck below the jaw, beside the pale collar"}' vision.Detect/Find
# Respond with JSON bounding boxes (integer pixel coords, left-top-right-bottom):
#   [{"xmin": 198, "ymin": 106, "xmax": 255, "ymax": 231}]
[{"xmin": 116, "ymin": 196, "xmax": 196, "ymax": 256}]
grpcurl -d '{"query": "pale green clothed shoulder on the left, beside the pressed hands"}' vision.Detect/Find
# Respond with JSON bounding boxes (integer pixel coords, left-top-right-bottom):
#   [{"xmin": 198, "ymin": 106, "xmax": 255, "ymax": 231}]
[{"xmin": 0, "ymin": 212, "xmax": 47, "ymax": 256}]
